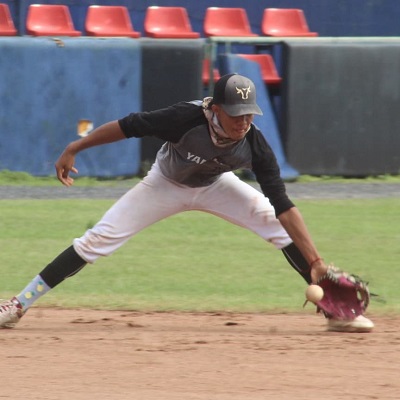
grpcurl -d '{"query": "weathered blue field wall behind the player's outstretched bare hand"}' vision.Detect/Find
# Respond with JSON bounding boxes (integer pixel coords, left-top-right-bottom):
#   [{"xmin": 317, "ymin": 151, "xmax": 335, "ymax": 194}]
[{"xmin": 0, "ymin": 37, "xmax": 141, "ymax": 176}]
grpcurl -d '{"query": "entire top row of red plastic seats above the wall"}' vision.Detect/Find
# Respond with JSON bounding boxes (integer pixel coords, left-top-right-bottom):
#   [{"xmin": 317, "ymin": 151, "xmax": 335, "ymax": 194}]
[{"xmin": 0, "ymin": 4, "xmax": 318, "ymax": 39}]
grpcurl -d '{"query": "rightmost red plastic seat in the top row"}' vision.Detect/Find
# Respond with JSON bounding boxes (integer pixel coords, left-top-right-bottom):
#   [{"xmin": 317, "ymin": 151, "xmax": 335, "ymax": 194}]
[{"xmin": 261, "ymin": 8, "xmax": 318, "ymax": 37}]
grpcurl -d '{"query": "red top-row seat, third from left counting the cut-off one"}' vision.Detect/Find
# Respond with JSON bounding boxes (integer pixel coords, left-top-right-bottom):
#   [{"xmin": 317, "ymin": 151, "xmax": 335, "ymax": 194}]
[{"xmin": 85, "ymin": 6, "xmax": 140, "ymax": 38}]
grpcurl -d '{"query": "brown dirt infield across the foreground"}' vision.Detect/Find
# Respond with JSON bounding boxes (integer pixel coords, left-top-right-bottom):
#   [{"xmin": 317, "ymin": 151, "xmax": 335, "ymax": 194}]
[{"xmin": 0, "ymin": 308, "xmax": 400, "ymax": 400}]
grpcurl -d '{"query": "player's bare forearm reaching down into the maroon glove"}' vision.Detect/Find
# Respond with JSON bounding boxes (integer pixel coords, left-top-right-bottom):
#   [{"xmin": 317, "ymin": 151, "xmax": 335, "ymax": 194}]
[{"xmin": 278, "ymin": 207, "xmax": 327, "ymax": 283}]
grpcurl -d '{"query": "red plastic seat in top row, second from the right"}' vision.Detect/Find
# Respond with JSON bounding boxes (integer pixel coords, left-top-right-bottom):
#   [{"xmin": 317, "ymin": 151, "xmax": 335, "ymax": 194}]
[{"xmin": 203, "ymin": 7, "xmax": 258, "ymax": 37}]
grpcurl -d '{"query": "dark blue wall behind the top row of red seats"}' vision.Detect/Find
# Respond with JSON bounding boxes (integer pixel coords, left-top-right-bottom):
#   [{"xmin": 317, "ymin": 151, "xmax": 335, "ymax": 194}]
[{"xmin": 2, "ymin": 0, "xmax": 400, "ymax": 36}]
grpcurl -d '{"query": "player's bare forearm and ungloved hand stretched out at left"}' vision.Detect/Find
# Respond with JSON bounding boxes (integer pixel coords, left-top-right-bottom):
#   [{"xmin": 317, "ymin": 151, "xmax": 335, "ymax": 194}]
[{"xmin": 55, "ymin": 121, "xmax": 126, "ymax": 186}]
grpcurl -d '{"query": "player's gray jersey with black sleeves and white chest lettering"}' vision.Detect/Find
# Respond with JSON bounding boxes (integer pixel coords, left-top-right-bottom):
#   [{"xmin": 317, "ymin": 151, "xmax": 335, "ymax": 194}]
[{"xmin": 119, "ymin": 101, "xmax": 293, "ymax": 215}]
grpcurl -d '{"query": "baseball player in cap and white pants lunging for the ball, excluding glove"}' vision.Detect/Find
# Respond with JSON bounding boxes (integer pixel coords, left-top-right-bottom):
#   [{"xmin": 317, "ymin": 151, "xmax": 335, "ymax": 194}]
[{"xmin": 0, "ymin": 74, "xmax": 374, "ymax": 331}]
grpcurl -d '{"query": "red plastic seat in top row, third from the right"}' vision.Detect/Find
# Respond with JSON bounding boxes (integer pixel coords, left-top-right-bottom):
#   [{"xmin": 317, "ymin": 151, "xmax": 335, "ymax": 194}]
[{"xmin": 144, "ymin": 6, "xmax": 200, "ymax": 39}]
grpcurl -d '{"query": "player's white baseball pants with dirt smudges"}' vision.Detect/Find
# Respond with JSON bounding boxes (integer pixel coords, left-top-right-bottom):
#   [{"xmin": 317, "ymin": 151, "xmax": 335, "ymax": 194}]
[{"xmin": 73, "ymin": 164, "xmax": 292, "ymax": 263}]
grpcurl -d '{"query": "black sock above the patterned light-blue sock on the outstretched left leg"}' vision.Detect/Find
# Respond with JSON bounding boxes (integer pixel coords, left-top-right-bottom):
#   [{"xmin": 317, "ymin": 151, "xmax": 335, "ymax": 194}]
[{"xmin": 39, "ymin": 246, "xmax": 86, "ymax": 288}]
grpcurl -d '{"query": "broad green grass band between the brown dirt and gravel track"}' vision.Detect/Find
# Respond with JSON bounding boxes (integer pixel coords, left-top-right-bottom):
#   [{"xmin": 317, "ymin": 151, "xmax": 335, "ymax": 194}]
[{"xmin": 0, "ymin": 199, "xmax": 400, "ymax": 313}]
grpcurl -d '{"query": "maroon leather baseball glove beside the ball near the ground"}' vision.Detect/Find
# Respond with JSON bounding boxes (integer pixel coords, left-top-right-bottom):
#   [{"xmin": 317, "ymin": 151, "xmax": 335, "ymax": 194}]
[{"xmin": 310, "ymin": 265, "xmax": 371, "ymax": 320}]
